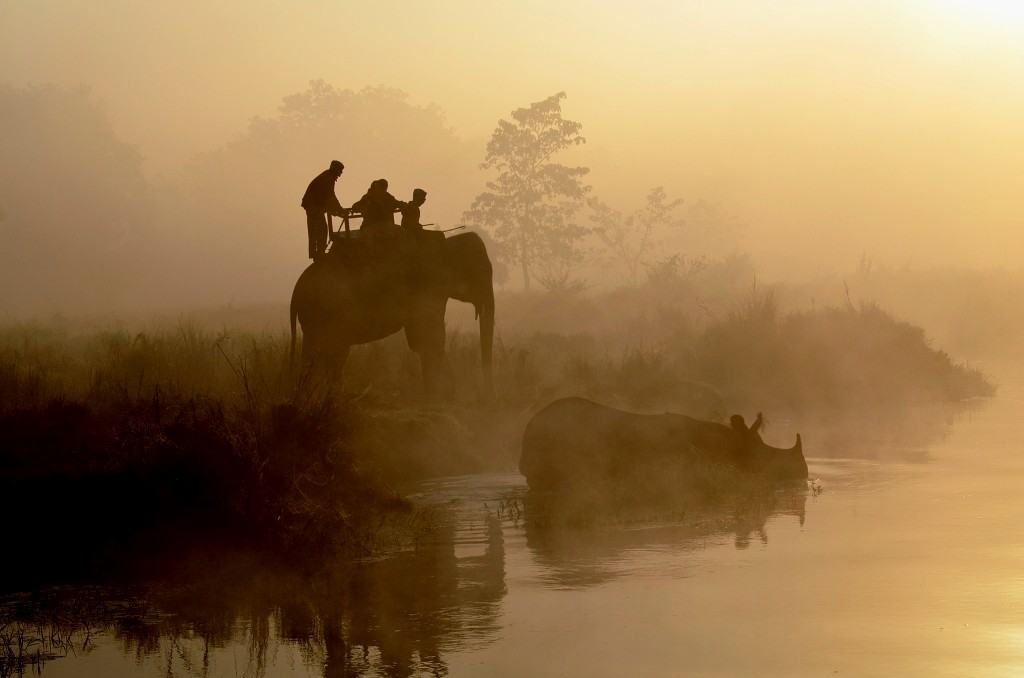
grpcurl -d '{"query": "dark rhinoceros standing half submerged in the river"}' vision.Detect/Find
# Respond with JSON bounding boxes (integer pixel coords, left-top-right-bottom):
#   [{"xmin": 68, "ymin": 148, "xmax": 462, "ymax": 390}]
[{"xmin": 519, "ymin": 397, "xmax": 807, "ymax": 489}]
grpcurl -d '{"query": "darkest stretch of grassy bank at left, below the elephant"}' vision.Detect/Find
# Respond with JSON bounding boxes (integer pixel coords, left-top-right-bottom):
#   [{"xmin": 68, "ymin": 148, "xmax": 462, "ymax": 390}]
[{"xmin": 0, "ymin": 326, "xmax": 460, "ymax": 573}]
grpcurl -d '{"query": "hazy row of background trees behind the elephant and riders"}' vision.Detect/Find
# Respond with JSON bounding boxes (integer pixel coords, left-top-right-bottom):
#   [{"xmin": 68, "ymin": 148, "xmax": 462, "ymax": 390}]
[{"xmin": 0, "ymin": 81, "xmax": 735, "ymax": 313}]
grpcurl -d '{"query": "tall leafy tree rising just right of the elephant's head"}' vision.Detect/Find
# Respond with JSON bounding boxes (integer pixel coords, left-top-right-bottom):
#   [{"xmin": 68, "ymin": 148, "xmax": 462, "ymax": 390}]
[{"xmin": 464, "ymin": 92, "xmax": 590, "ymax": 290}]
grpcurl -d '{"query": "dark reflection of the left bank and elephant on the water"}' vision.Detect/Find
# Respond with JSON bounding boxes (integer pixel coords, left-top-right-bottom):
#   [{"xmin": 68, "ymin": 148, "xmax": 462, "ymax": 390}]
[{"xmin": 0, "ymin": 516, "xmax": 505, "ymax": 678}]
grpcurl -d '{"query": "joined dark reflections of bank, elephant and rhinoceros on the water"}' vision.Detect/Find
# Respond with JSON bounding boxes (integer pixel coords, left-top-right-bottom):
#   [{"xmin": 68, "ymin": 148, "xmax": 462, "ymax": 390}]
[{"xmin": 0, "ymin": 476, "xmax": 808, "ymax": 678}]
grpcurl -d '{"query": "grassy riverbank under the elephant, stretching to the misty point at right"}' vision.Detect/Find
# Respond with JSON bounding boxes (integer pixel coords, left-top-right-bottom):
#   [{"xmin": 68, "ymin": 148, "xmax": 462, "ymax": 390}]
[{"xmin": 0, "ymin": 276, "xmax": 993, "ymax": 571}]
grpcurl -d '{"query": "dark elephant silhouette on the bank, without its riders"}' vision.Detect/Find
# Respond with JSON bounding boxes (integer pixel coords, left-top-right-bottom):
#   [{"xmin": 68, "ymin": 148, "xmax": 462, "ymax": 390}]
[{"xmin": 291, "ymin": 231, "xmax": 495, "ymax": 392}]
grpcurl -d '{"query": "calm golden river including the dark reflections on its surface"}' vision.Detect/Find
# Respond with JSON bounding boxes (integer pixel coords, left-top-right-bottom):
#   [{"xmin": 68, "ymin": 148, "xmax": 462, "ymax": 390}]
[{"xmin": 0, "ymin": 372, "xmax": 1024, "ymax": 678}]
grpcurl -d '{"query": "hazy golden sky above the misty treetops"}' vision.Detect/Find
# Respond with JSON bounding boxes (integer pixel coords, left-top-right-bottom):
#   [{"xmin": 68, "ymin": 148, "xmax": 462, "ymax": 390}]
[{"xmin": 0, "ymin": 0, "xmax": 1024, "ymax": 274}]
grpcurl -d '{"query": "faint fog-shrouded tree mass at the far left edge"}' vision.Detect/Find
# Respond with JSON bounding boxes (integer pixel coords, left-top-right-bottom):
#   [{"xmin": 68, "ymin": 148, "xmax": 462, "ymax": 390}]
[{"xmin": 0, "ymin": 85, "xmax": 152, "ymax": 312}]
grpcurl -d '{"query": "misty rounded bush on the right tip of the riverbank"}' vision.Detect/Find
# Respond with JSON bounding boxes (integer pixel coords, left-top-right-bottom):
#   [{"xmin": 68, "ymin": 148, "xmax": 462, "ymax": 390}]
[{"xmin": 691, "ymin": 294, "xmax": 994, "ymax": 409}]
